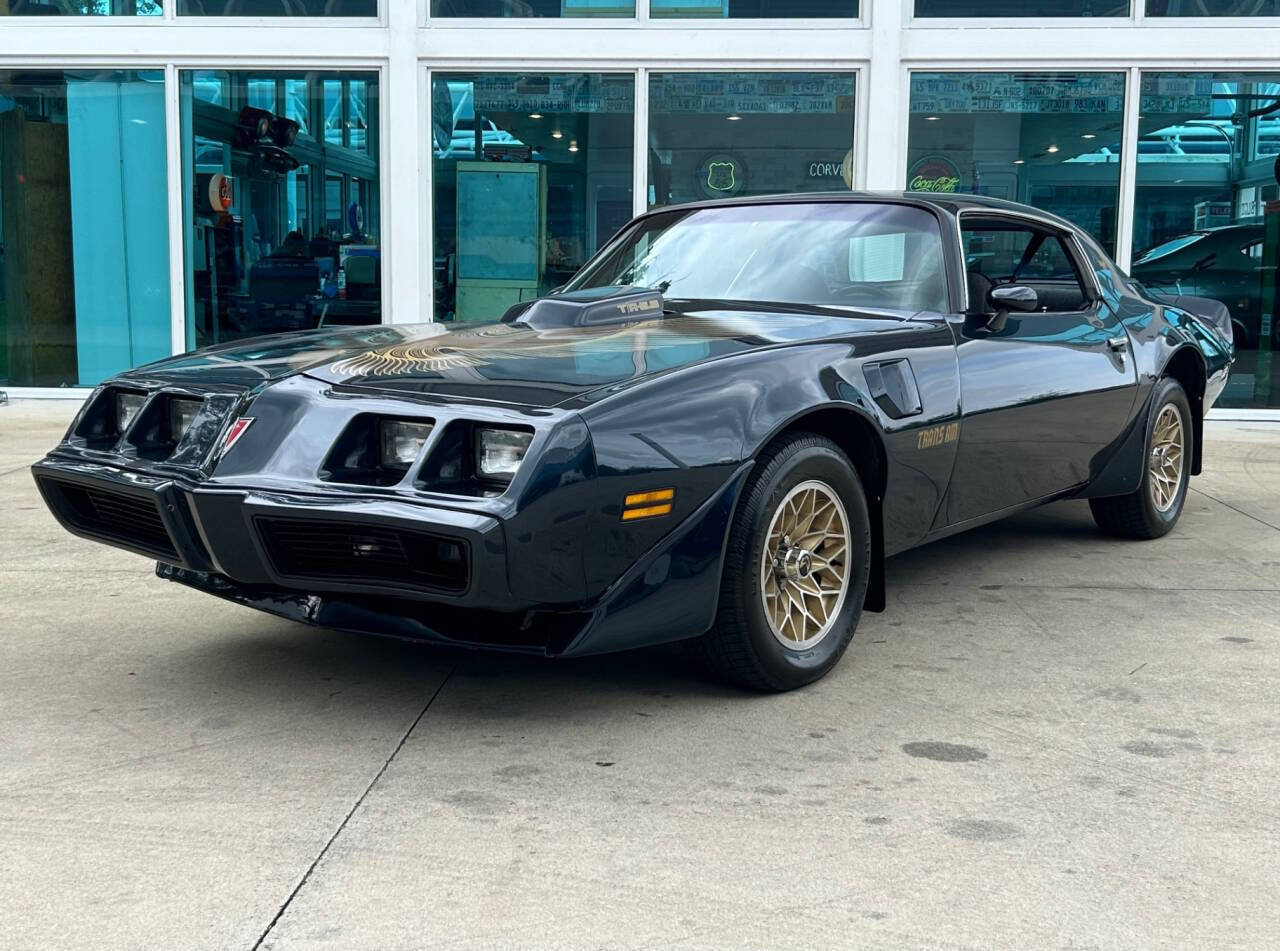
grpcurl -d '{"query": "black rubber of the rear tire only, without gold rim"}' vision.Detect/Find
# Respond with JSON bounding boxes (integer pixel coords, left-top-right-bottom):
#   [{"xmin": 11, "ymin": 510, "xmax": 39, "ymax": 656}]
[{"xmin": 1089, "ymin": 376, "xmax": 1194, "ymax": 539}]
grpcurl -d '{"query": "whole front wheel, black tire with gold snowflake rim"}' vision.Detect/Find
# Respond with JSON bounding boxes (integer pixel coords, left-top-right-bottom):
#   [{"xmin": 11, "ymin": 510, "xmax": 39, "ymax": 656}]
[{"xmin": 694, "ymin": 434, "xmax": 870, "ymax": 691}]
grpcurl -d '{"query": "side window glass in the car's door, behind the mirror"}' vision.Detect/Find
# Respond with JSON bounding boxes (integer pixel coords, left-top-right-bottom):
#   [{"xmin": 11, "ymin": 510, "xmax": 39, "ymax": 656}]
[{"xmin": 960, "ymin": 218, "xmax": 1091, "ymax": 312}]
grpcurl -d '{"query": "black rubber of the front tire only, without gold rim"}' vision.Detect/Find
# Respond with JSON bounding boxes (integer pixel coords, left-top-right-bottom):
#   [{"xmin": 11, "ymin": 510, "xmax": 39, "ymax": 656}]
[{"xmin": 690, "ymin": 433, "xmax": 872, "ymax": 691}]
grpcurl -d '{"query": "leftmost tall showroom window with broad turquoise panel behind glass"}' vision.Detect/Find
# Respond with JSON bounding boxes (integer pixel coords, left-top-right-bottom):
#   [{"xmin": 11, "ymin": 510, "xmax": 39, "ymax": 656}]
[{"xmin": 0, "ymin": 69, "xmax": 172, "ymax": 387}]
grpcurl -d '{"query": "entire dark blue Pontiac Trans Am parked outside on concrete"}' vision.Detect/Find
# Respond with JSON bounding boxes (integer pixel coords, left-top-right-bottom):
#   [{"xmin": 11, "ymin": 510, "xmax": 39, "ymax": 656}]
[{"xmin": 33, "ymin": 193, "xmax": 1233, "ymax": 690}]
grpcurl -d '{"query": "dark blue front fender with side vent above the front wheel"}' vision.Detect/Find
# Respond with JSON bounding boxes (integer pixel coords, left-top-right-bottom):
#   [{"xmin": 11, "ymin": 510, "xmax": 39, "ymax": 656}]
[{"xmin": 580, "ymin": 324, "xmax": 959, "ymax": 591}]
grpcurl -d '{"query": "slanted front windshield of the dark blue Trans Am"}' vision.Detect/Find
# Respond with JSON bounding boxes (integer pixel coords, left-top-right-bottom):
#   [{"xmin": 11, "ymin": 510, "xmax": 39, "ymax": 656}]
[{"xmin": 566, "ymin": 202, "xmax": 947, "ymax": 312}]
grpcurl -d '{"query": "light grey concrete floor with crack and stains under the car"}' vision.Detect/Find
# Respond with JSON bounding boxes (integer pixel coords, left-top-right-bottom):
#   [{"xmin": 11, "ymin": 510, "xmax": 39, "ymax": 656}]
[{"xmin": 0, "ymin": 404, "xmax": 1280, "ymax": 951}]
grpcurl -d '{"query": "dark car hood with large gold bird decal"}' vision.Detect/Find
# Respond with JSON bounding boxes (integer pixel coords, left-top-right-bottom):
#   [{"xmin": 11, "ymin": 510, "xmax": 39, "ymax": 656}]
[{"xmin": 125, "ymin": 307, "xmax": 931, "ymax": 407}]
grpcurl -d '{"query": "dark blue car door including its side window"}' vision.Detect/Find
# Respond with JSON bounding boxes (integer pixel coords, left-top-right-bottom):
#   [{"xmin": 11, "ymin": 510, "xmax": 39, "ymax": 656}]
[{"xmin": 934, "ymin": 210, "xmax": 1137, "ymax": 529}]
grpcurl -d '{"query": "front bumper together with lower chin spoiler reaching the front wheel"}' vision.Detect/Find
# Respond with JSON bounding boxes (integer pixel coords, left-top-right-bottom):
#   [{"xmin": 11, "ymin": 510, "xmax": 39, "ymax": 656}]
[{"xmin": 32, "ymin": 454, "xmax": 750, "ymax": 655}]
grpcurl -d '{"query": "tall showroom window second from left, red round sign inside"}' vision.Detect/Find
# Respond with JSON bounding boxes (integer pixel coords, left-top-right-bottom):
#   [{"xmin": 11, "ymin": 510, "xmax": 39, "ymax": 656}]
[{"xmin": 179, "ymin": 70, "xmax": 381, "ymax": 348}]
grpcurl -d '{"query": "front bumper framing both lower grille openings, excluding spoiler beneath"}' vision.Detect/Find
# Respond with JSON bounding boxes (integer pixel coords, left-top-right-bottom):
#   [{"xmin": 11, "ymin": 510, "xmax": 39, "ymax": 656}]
[{"xmin": 32, "ymin": 457, "xmax": 522, "ymax": 611}]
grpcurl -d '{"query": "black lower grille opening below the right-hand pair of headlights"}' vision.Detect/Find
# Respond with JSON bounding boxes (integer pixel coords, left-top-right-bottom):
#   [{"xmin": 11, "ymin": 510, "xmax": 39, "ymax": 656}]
[{"xmin": 256, "ymin": 518, "xmax": 468, "ymax": 591}]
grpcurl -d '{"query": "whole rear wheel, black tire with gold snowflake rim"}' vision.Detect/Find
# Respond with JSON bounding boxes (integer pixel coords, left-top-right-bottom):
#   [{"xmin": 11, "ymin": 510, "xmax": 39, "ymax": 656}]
[{"xmin": 1089, "ymin": 378, "xmax": 1193, "ymax": 539}]
